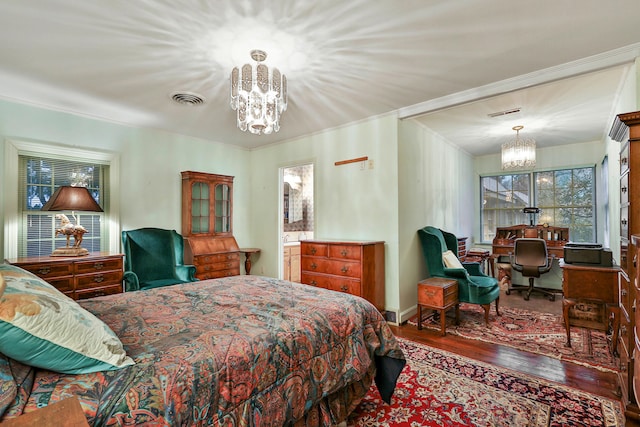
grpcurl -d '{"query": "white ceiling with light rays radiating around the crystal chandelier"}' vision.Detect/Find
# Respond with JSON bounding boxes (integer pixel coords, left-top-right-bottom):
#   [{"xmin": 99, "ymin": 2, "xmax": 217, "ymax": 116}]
[{"xmin": 0, "ymin": 0, "xmax": 640, "ymax": 155}]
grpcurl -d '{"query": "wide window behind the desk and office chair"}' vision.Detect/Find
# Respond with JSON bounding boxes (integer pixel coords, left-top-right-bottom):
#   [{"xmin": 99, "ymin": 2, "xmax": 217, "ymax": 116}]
[{"xmin": 480, "ymin": 167, "xmax": 596, "ymax": 242}]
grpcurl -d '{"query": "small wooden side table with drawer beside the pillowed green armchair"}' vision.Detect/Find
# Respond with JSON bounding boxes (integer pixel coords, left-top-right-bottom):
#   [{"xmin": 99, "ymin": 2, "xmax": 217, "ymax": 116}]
[{"xmin": 418, "ymin": 277, "xmax": 460, "ymax": 336}]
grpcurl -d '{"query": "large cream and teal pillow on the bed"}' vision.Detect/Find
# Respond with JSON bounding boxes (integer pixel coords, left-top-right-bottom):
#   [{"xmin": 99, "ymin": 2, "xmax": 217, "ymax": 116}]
[{"xmin": 0, "ymin": 264, "xmax": 134, "ymax": 374}]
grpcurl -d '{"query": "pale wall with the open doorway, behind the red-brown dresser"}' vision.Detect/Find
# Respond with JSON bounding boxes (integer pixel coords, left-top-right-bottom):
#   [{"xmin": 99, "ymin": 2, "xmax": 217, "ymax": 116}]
[{"xmin": 251, "ymin": 115, "xmax": 399, "ymax": 311}]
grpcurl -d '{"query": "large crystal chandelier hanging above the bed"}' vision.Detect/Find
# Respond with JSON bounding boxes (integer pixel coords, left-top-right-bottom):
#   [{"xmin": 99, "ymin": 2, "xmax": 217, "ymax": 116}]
[{"xmin": 231, "ymin": 50, "xmax": 287, "ymax": 135}]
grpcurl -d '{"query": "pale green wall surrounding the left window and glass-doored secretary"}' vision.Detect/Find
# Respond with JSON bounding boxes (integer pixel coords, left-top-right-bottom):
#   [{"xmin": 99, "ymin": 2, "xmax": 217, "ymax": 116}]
[{"xmin": 0, "ymin": 101, "xmax": 254, "ymax": 259}]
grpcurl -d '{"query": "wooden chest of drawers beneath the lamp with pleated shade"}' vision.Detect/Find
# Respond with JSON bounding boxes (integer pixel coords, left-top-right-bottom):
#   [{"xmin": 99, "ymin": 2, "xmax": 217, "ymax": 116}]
[{"xmin": 7, "ymin": 252, "xmax": 123, "ymax": 300}]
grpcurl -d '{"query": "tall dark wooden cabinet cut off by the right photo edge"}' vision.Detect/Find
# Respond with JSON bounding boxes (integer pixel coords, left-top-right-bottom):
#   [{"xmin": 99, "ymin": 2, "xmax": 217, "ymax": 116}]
[{"xmin": 609, "ymin": 111, "xmax": 640, "ymax": 421}]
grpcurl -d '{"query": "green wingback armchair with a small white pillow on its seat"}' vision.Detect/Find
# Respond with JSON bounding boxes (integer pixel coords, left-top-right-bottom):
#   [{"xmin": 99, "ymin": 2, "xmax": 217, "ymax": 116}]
[{"xmin": 418, "ymin": 226, "xmax": 500, "ymax": 324}]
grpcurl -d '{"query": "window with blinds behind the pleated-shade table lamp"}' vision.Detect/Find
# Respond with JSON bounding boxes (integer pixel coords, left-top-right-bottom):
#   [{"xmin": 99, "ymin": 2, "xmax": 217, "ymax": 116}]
[{"xmin": 18, "ymin": 154, "xmax": 109, "ymax": 256}]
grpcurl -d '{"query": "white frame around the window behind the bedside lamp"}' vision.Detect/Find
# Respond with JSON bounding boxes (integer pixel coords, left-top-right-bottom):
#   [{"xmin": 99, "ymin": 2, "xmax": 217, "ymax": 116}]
[{"xmin": 2, "ymin": 139, "xmax": 120, "ymax": 259}]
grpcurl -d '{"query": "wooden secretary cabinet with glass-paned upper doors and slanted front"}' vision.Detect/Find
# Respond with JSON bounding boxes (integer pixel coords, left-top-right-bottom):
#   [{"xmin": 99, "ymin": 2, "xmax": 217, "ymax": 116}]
[{"xmin": 182, "ymin": 171, "xmax": 240, "ymax": 280}]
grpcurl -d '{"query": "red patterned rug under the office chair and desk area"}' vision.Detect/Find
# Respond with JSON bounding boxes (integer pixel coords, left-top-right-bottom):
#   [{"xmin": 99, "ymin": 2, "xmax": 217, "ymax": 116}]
[{"xmin": 408, "ymin": 303, "xmax": 618, "ymax": 372}]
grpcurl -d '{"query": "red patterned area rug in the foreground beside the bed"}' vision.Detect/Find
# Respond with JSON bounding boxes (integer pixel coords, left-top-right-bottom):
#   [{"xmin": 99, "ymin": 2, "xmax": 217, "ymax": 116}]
[{"xmin": 347, "ymin": 339, "xmax": 624, "ymax": 427}]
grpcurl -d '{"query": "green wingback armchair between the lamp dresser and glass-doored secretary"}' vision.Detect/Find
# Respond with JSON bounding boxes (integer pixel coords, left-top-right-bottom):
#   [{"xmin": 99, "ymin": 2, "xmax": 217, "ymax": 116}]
[{"xmin": 122, "ymin": 228, "xmax": 198, "ymax": 291}]
